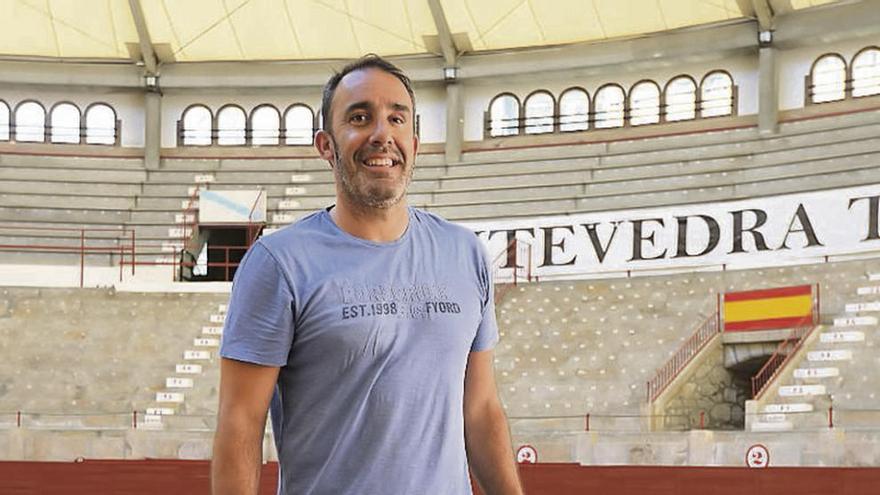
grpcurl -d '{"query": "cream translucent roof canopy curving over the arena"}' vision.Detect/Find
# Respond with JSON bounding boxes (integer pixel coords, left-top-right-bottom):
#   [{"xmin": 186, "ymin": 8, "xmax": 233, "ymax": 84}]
[{"xmin": 0, "ymin": 0, "xmax": 834, "ymax": 63}]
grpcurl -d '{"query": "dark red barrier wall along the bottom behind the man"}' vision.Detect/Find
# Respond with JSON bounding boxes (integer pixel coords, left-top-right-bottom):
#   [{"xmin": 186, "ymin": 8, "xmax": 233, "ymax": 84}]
[{"xmin": 0, "ymin": 460, "xmax": 880, "ymax": 495}]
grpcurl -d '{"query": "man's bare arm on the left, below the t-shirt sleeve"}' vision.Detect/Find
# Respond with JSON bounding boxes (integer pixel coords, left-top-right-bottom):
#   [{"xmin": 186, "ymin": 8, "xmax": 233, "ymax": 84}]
[{"xmin": 211, "ymin": 358, "xmax": 279, "ymax": 495}]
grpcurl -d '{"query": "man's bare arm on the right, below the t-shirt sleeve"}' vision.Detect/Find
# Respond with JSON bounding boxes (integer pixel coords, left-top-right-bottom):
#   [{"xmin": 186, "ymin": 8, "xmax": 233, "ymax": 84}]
[{"xmin": 464, "ymin": 350, "xmax": 523, "ymax": 495}]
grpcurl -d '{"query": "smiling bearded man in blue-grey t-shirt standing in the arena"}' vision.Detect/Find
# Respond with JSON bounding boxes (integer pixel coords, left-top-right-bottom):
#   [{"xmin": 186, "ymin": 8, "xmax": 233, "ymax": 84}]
[{"xmin": 212, "ymin": 56, "xmax": 522, "ymax": 495}]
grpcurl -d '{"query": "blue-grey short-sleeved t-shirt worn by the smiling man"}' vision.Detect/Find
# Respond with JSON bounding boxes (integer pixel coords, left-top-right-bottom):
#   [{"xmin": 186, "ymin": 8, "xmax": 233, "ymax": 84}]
[{"xmin": 220, "ymin": 208, "xmax": 498, "ymax": 495}]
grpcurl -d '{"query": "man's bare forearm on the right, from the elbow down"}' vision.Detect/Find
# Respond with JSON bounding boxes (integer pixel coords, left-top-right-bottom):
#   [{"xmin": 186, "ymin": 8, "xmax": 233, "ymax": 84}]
[{"xmin": 465, "ymin": 405, "xmax": 523, "ymax": 495}]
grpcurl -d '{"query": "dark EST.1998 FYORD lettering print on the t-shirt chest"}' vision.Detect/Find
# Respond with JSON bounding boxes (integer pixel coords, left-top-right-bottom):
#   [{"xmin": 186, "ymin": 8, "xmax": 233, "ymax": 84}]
[{"xmin": 337, "ymin": 283, "xmax": 461, "ymax": 320}]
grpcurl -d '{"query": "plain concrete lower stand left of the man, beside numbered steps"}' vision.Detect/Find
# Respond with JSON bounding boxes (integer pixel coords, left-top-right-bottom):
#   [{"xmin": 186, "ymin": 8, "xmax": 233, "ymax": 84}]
[{"xmin": 0, "ymin": 287, "xmax": 228, "ymax": 418}]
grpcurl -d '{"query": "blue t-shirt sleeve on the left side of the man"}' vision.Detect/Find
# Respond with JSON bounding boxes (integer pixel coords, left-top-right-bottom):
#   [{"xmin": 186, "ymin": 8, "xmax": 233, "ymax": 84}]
[{"xmin": 220, "ymin": 242, "xmax": 294, "ymax": 366}]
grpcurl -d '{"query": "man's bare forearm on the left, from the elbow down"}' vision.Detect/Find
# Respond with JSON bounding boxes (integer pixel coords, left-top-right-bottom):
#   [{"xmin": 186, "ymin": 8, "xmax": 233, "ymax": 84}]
[{"xmin": 211, "ymin": 418, "xmax": 263, "ymax": 495}]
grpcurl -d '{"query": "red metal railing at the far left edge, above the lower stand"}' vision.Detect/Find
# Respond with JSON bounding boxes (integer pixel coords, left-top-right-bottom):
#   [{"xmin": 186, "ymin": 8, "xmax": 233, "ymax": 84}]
[{"xmin": 0, "ymin": 225, "xmax": 137, "ymax": 287}]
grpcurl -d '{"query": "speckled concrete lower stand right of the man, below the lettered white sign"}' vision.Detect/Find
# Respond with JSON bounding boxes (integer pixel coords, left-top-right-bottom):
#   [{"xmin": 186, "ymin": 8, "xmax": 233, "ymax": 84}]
[{"xmin": 496, "ymin": 254, "xmax": 880, "ymax": 428}]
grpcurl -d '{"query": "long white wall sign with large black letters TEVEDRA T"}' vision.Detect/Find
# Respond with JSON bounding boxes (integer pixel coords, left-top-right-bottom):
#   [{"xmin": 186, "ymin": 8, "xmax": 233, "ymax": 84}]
[{"xmin": 464, "ymin": 184, "xmax": 880, "ymax": 279}]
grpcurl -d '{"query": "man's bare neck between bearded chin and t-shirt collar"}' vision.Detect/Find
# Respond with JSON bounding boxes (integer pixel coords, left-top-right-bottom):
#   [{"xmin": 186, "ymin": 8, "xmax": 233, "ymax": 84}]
[{"xmin": 330, "ymin": 197, "xmax": 409, "ymax": 242}]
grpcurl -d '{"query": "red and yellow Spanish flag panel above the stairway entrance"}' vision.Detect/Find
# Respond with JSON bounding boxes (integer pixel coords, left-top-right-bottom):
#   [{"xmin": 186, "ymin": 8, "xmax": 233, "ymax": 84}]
[{"xmin": 724, "ymin": 285, "xmax": 813, "ymax": 332}]
